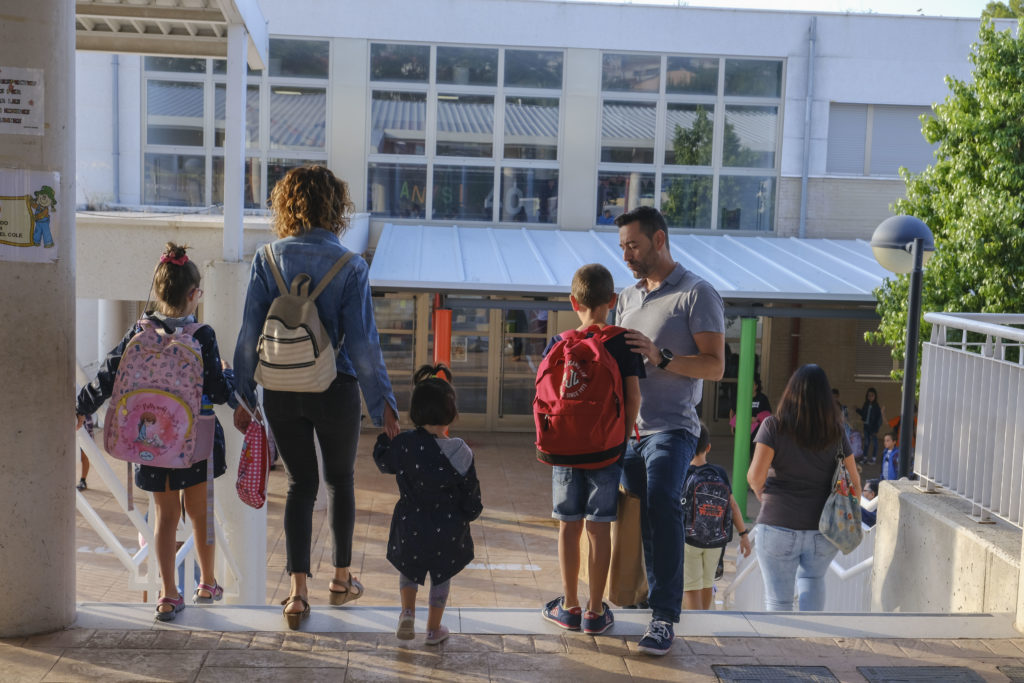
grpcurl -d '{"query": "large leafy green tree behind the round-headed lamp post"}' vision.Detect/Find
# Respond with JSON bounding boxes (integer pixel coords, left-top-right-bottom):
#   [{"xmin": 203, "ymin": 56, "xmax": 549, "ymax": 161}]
[{"xmin": 866, "ymin": 19, "xmax": 1024, "ymax": 379}]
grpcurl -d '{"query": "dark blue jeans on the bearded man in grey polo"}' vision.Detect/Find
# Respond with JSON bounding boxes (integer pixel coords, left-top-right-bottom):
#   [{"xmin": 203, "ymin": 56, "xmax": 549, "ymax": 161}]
[{"xmin": 623, "ymin": 429, "xmax": 697, "ymax": 624}]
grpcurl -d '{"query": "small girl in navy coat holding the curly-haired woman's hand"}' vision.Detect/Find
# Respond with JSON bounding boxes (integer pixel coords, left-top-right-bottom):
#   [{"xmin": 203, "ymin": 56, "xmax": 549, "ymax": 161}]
[{"xmin": 374, "ymin": 366, "xmax": 483, "ymax": 645}]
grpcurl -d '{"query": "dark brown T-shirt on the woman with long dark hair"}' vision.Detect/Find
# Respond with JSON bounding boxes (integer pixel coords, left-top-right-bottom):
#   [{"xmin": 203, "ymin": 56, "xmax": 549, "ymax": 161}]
[{"xmin": 754, "ymin": 415, "xmax": 853, "ymax": 530}]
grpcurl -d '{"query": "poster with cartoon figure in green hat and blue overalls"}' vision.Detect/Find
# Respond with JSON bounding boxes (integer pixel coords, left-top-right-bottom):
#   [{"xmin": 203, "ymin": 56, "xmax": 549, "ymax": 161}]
[{"xmin": 0, "ymin": 168, "xmax": 59, "ymax": 263}]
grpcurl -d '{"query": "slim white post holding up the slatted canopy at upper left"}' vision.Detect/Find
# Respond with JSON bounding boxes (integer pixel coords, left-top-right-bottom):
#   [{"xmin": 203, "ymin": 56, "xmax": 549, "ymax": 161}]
[{"xmin": 223, "ymin": 24, "xmax": 249, "ymax": 262}]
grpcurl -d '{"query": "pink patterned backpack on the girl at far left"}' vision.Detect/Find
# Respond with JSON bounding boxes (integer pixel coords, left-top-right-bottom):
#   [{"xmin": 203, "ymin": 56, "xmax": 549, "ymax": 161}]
[{"xmin": 103, "ymin": 318, "xmax": 214, "ymax": 469}]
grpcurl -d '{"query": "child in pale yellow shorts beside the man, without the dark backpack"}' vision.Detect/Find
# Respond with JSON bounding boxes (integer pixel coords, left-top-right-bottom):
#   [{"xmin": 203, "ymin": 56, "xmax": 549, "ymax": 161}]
[{"xmin": 683, "ymin": 423, "xmax": 751, "ymax": 609}]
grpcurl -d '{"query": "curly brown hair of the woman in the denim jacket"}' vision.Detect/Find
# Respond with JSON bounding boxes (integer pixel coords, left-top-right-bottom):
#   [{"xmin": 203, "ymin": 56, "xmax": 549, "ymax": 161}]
[{"xmin": 270, "ymin": 165, "xmax": 355, "ymax": 238}]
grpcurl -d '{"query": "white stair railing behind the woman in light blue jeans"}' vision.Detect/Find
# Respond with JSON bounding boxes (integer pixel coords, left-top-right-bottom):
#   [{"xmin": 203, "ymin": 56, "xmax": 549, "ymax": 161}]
[{"xmin": 722, "ymin": 526, "xmax": 874, "ymax": 612}]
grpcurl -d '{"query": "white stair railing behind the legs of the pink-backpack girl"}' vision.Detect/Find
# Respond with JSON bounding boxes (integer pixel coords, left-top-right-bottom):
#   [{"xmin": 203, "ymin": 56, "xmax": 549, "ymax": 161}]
[{"xmin": 75, "ymin": 367, "xmax": 242, "ymax": 600}]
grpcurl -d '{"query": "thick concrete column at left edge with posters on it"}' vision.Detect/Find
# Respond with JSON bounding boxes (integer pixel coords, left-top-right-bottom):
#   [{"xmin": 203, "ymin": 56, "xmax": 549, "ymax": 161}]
[{"xmin": 0, "ymin": 0, "xmax": 77, "ymax": 637}]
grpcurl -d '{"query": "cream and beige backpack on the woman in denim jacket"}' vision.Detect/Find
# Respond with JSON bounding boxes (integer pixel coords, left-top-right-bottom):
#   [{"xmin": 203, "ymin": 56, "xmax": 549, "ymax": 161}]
[{"xmin": 255, "ymin": 245, "xmax": 352, "ymax": 393}]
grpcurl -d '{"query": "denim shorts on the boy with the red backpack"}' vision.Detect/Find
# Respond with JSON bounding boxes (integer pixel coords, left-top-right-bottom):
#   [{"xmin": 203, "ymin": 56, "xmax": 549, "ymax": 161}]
[{"xmin": 551, "ymin": 459, "xmax": 623, "ymax": 522}]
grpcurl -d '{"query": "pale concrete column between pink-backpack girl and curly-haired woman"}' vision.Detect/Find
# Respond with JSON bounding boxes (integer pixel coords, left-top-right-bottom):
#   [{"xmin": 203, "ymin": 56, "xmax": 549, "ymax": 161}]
[{"xmin": 201, "ymin": 261, "xmax": 266, "ymax": 605}]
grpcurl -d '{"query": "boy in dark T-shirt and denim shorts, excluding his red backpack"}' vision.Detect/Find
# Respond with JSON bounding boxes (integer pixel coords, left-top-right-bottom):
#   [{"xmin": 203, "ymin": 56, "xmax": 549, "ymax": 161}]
[{"xmin": 538, "ymin": 263, "xmax": 644, "ymax": 634}]
